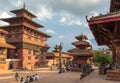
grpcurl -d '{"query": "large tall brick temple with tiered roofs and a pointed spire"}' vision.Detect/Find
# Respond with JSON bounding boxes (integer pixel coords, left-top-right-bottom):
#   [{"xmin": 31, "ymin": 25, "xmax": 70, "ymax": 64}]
[{"xmin": 0, "ymin": 4, "xmax": 51, "ymax": 69}]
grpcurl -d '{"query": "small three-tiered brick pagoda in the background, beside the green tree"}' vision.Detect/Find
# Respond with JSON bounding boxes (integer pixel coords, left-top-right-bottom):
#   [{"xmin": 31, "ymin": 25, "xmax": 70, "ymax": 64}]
[{"xmin": 68, "ymin": 34, "xmax": 93, "ymax": 71}]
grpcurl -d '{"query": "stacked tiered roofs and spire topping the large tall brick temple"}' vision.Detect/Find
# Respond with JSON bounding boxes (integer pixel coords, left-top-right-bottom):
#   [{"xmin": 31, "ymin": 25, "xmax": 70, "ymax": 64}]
[{"xmin": 0, "ymin": 4, "xmax": 51, "ymax": 38}]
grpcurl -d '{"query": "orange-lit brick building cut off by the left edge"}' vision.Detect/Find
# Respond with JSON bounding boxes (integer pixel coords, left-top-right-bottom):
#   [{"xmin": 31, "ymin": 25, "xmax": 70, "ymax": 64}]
[{"xmin": 0, "ymin": 29, "xmax": 17, "ymax": 70}]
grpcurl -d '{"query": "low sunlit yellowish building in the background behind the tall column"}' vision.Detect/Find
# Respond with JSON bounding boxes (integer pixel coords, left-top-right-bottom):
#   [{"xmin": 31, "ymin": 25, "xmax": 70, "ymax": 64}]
[{"xmin": 44, "ymin": 47, "xmax": 73, "ymax": 67}]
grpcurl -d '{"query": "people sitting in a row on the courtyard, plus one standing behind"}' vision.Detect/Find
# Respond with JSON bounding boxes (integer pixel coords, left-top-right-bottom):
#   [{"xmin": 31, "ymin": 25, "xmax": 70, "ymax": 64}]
[{"xmin": 15, "ymin": 73, "xmax": 39, "ymax": 83}]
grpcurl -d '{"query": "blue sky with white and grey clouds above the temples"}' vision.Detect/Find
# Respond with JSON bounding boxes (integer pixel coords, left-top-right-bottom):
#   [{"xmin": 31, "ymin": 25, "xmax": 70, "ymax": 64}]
[{"xmin": 0, "ymin": 0, "xmax": 110, "ymax": 51}]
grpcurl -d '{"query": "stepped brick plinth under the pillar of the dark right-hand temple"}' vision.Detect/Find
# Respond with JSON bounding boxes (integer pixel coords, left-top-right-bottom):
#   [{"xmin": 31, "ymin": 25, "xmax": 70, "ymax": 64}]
[{"xmin": 106, "ymin": 69, "xmax": 120, "ymax": 80}]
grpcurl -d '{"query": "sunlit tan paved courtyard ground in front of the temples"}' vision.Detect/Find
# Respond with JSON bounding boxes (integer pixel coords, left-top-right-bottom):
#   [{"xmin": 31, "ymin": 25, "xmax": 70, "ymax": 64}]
[{"xmin": 0, "ymin": 70, "xmax": 120, "ymax": 83}]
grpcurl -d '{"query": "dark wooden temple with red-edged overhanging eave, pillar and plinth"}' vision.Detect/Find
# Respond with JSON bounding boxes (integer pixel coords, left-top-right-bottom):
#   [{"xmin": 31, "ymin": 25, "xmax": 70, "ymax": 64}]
[{"xmin": 86, "ymin": 0, "xmax": 120, "ymax": 80}]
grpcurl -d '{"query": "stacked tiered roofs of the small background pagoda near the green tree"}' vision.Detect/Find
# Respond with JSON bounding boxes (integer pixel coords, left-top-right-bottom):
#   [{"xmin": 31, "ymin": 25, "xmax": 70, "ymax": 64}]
[{"xmin": 68, "ymin": 34, "xmax": 93, "ymax": 57}]
